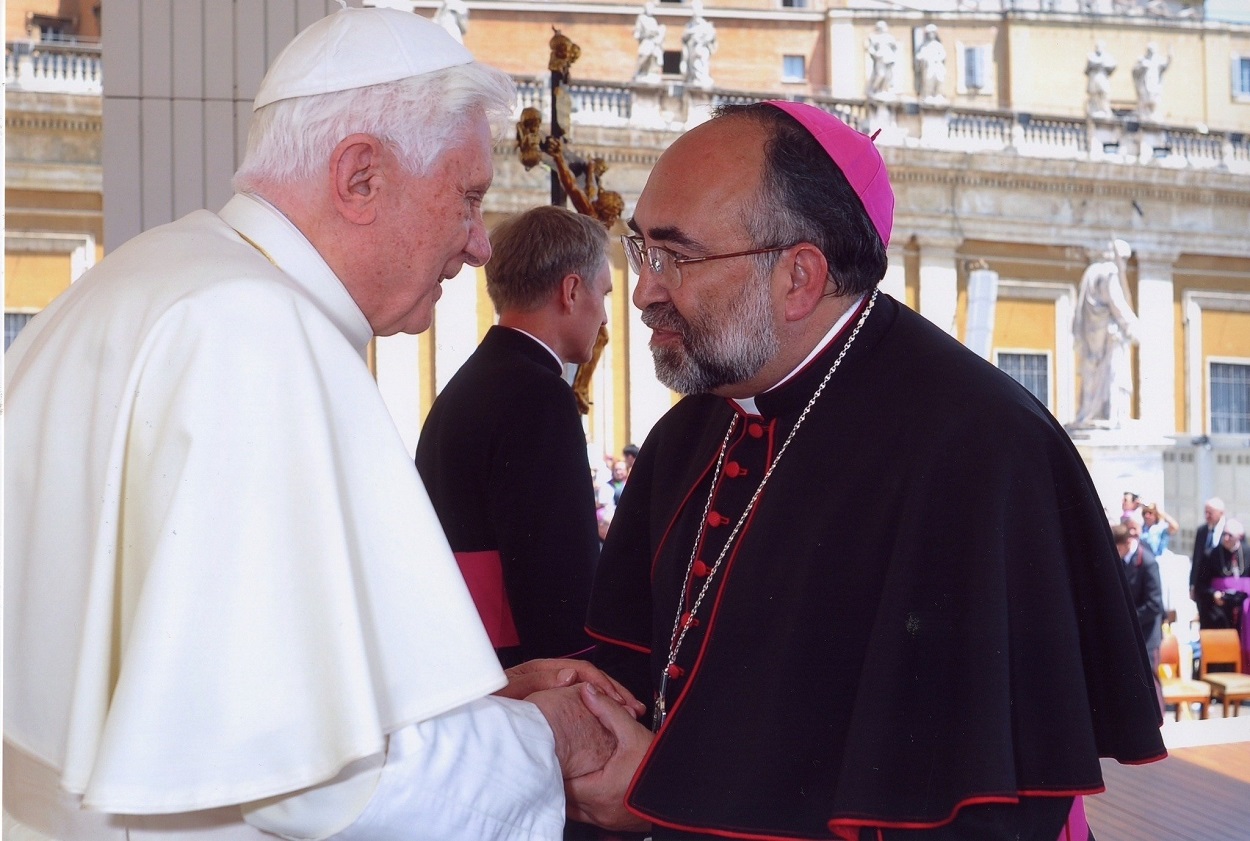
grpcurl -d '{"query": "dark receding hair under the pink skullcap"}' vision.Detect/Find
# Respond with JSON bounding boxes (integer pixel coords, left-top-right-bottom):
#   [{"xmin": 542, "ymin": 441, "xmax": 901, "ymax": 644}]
[{"xmin": 715, "ymin": 102, "xmax": 886, "ymax": 295}]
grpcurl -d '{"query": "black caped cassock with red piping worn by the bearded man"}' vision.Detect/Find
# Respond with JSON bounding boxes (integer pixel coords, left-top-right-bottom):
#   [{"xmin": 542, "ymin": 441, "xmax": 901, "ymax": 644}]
[{"xmin": 589, "ymin": 295, "xmax": 1164, "ymax": 841}]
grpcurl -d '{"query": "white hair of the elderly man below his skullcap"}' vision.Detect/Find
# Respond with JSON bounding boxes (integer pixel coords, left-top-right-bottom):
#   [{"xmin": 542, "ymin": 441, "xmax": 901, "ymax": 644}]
[{"xmin": 233, "ymin": 61, "xmax": 516, "ymax": 195}]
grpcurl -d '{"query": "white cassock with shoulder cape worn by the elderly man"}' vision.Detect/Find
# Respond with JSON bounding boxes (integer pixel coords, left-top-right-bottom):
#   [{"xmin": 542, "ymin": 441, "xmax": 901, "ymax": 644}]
[{"xmin": 4, "ymin": 196, "xmax": 564, "ymax": 841}]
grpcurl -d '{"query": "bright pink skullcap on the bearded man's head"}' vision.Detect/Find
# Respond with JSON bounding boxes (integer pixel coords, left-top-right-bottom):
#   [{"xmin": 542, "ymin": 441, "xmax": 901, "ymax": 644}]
[{"xmin": 765, "ymin": 100, "xmax": 894, "ymax": 245}]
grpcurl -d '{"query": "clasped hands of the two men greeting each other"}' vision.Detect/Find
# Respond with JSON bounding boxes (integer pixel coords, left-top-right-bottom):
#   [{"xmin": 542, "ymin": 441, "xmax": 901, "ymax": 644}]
[{"xmin": 496, "ymin": 660, "xmax": 651, "ymax": 830}]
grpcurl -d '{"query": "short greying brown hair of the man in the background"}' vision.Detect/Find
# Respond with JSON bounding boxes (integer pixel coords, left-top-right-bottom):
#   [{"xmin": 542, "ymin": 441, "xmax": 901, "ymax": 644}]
[{"xmin": 486, "ymin": 205, "xmax": 608, "ymax": 312}]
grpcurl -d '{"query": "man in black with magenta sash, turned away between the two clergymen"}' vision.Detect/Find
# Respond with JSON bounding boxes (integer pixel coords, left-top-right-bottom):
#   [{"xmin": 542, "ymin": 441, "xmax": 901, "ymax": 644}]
[{"xmin": 416, "ymin": 207, "xmax": 613, "ymax": 666}]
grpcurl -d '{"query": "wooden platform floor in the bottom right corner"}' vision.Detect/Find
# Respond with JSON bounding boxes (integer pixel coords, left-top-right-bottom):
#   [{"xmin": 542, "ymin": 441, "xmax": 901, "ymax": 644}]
[{"xmin": 1085, "ymin": 705, "xmax": 1250, "ymax": 841}]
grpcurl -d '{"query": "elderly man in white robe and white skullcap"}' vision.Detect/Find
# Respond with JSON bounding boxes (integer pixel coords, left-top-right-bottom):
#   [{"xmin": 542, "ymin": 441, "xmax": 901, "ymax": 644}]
[{"xmin": 4, "ymin": 9, "xmax": 636, "ymax": 841}]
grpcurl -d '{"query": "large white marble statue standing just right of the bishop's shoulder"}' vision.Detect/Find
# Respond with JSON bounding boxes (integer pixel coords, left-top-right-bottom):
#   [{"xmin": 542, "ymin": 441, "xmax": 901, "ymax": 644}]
[{"xmin": 1073, "ymin": 240, "xmax": 1141, "ymax": 429}]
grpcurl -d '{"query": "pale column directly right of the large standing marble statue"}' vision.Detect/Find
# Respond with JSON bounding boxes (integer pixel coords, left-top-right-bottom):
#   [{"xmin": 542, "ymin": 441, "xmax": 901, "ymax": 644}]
[{"xmin": 1138, "ymin": 251, "xmax": 1176, "ymax": 435}]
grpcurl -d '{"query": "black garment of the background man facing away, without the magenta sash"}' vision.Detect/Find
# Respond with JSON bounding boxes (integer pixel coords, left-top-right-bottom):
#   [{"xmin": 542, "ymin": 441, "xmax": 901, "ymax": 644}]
[{"xmin": 416, "ymin": 326, "xmax": 599, "ymax": 666}]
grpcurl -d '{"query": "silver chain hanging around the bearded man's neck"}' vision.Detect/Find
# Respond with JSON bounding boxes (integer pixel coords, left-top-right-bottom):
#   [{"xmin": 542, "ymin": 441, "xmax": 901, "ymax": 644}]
[{"xmin": 654, "ymin": 289, "xmax": 876, "ymax": 730}]
